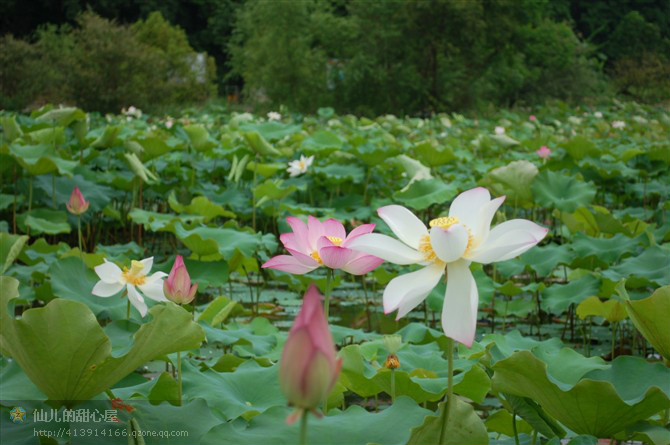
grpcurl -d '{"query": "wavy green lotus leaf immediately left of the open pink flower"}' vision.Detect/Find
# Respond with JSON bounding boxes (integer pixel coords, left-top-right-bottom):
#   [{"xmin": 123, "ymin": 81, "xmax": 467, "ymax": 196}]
[{"xmin": 174, "ymin": 223, "xmax": 272, "ymax": 260}]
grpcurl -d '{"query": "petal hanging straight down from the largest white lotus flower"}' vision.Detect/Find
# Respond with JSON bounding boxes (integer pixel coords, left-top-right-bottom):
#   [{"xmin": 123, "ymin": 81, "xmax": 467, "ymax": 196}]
[{"xmin": 442, "ymin": 260, "xmax": 479, "ymax": 347}]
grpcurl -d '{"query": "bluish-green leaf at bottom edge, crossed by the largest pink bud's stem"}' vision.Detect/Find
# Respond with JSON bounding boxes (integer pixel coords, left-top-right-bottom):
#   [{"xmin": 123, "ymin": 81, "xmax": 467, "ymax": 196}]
[{"xmin": 201, "ymin": 397, "xmax": 431, "ymax": 445}]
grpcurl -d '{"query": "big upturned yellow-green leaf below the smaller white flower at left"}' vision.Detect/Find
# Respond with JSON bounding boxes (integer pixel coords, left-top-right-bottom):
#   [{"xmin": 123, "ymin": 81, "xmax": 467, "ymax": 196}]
[{"xmin": 0, "ymin": 277, "xmax": 205, "ymax": 405}]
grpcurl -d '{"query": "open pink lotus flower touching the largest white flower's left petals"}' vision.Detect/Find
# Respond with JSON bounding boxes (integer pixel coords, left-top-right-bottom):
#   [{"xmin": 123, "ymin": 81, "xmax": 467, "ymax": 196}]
[{"xmin": 262, "ymin": 216, "xmax": 384, "ymax": 275}]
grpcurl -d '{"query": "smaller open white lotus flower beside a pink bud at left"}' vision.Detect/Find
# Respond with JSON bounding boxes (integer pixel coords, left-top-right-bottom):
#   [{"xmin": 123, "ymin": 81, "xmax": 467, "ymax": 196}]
[{"xmin": 91, "ymin": 257, "xmax": 167, "ymax": 317}]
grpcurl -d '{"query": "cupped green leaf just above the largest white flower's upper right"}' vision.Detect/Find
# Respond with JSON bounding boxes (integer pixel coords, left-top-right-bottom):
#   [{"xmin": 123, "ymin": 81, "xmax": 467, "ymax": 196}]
[{"xmin": 483, "ymin": 161, "xmax": 538, "ymax": 206}]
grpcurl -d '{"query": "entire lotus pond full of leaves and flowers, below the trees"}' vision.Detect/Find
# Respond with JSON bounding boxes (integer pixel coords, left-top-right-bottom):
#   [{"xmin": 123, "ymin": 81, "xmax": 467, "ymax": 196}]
[{"xmin": 0, "ymin": 101, "xmax": 670, "ymax": 445}]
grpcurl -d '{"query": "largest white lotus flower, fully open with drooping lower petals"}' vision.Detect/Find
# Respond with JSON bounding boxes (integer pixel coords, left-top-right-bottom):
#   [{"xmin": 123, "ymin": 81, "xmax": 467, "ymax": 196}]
[{"xmin": 349, "ymin": 187, "xmax": 548, "ymax": 347}]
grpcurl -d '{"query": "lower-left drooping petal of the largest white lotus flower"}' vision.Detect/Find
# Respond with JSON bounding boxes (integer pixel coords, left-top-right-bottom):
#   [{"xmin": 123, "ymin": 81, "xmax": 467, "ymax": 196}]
[{"xmin": 384, "ymin": 263, "xmax": 444, "ymax": 312}]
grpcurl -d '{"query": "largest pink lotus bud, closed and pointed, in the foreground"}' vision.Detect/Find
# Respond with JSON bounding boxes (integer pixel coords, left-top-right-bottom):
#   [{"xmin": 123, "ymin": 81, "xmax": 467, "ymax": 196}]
[{"xmin": 279, "ymin": 284, "xmax": 342, "ymax": 409}]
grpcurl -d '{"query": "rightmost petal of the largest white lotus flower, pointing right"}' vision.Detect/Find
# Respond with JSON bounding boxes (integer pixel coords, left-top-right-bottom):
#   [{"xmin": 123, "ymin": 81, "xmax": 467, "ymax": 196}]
[{"xmin": 467, "ymin": 219, "xmax": 549, "ymax": 264}]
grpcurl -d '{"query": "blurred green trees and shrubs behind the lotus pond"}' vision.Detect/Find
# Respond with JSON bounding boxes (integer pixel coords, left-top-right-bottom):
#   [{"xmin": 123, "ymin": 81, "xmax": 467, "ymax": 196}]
[{"xmin": 0, "ymin": 0, "xmax": 670, "ymax": 115}]
